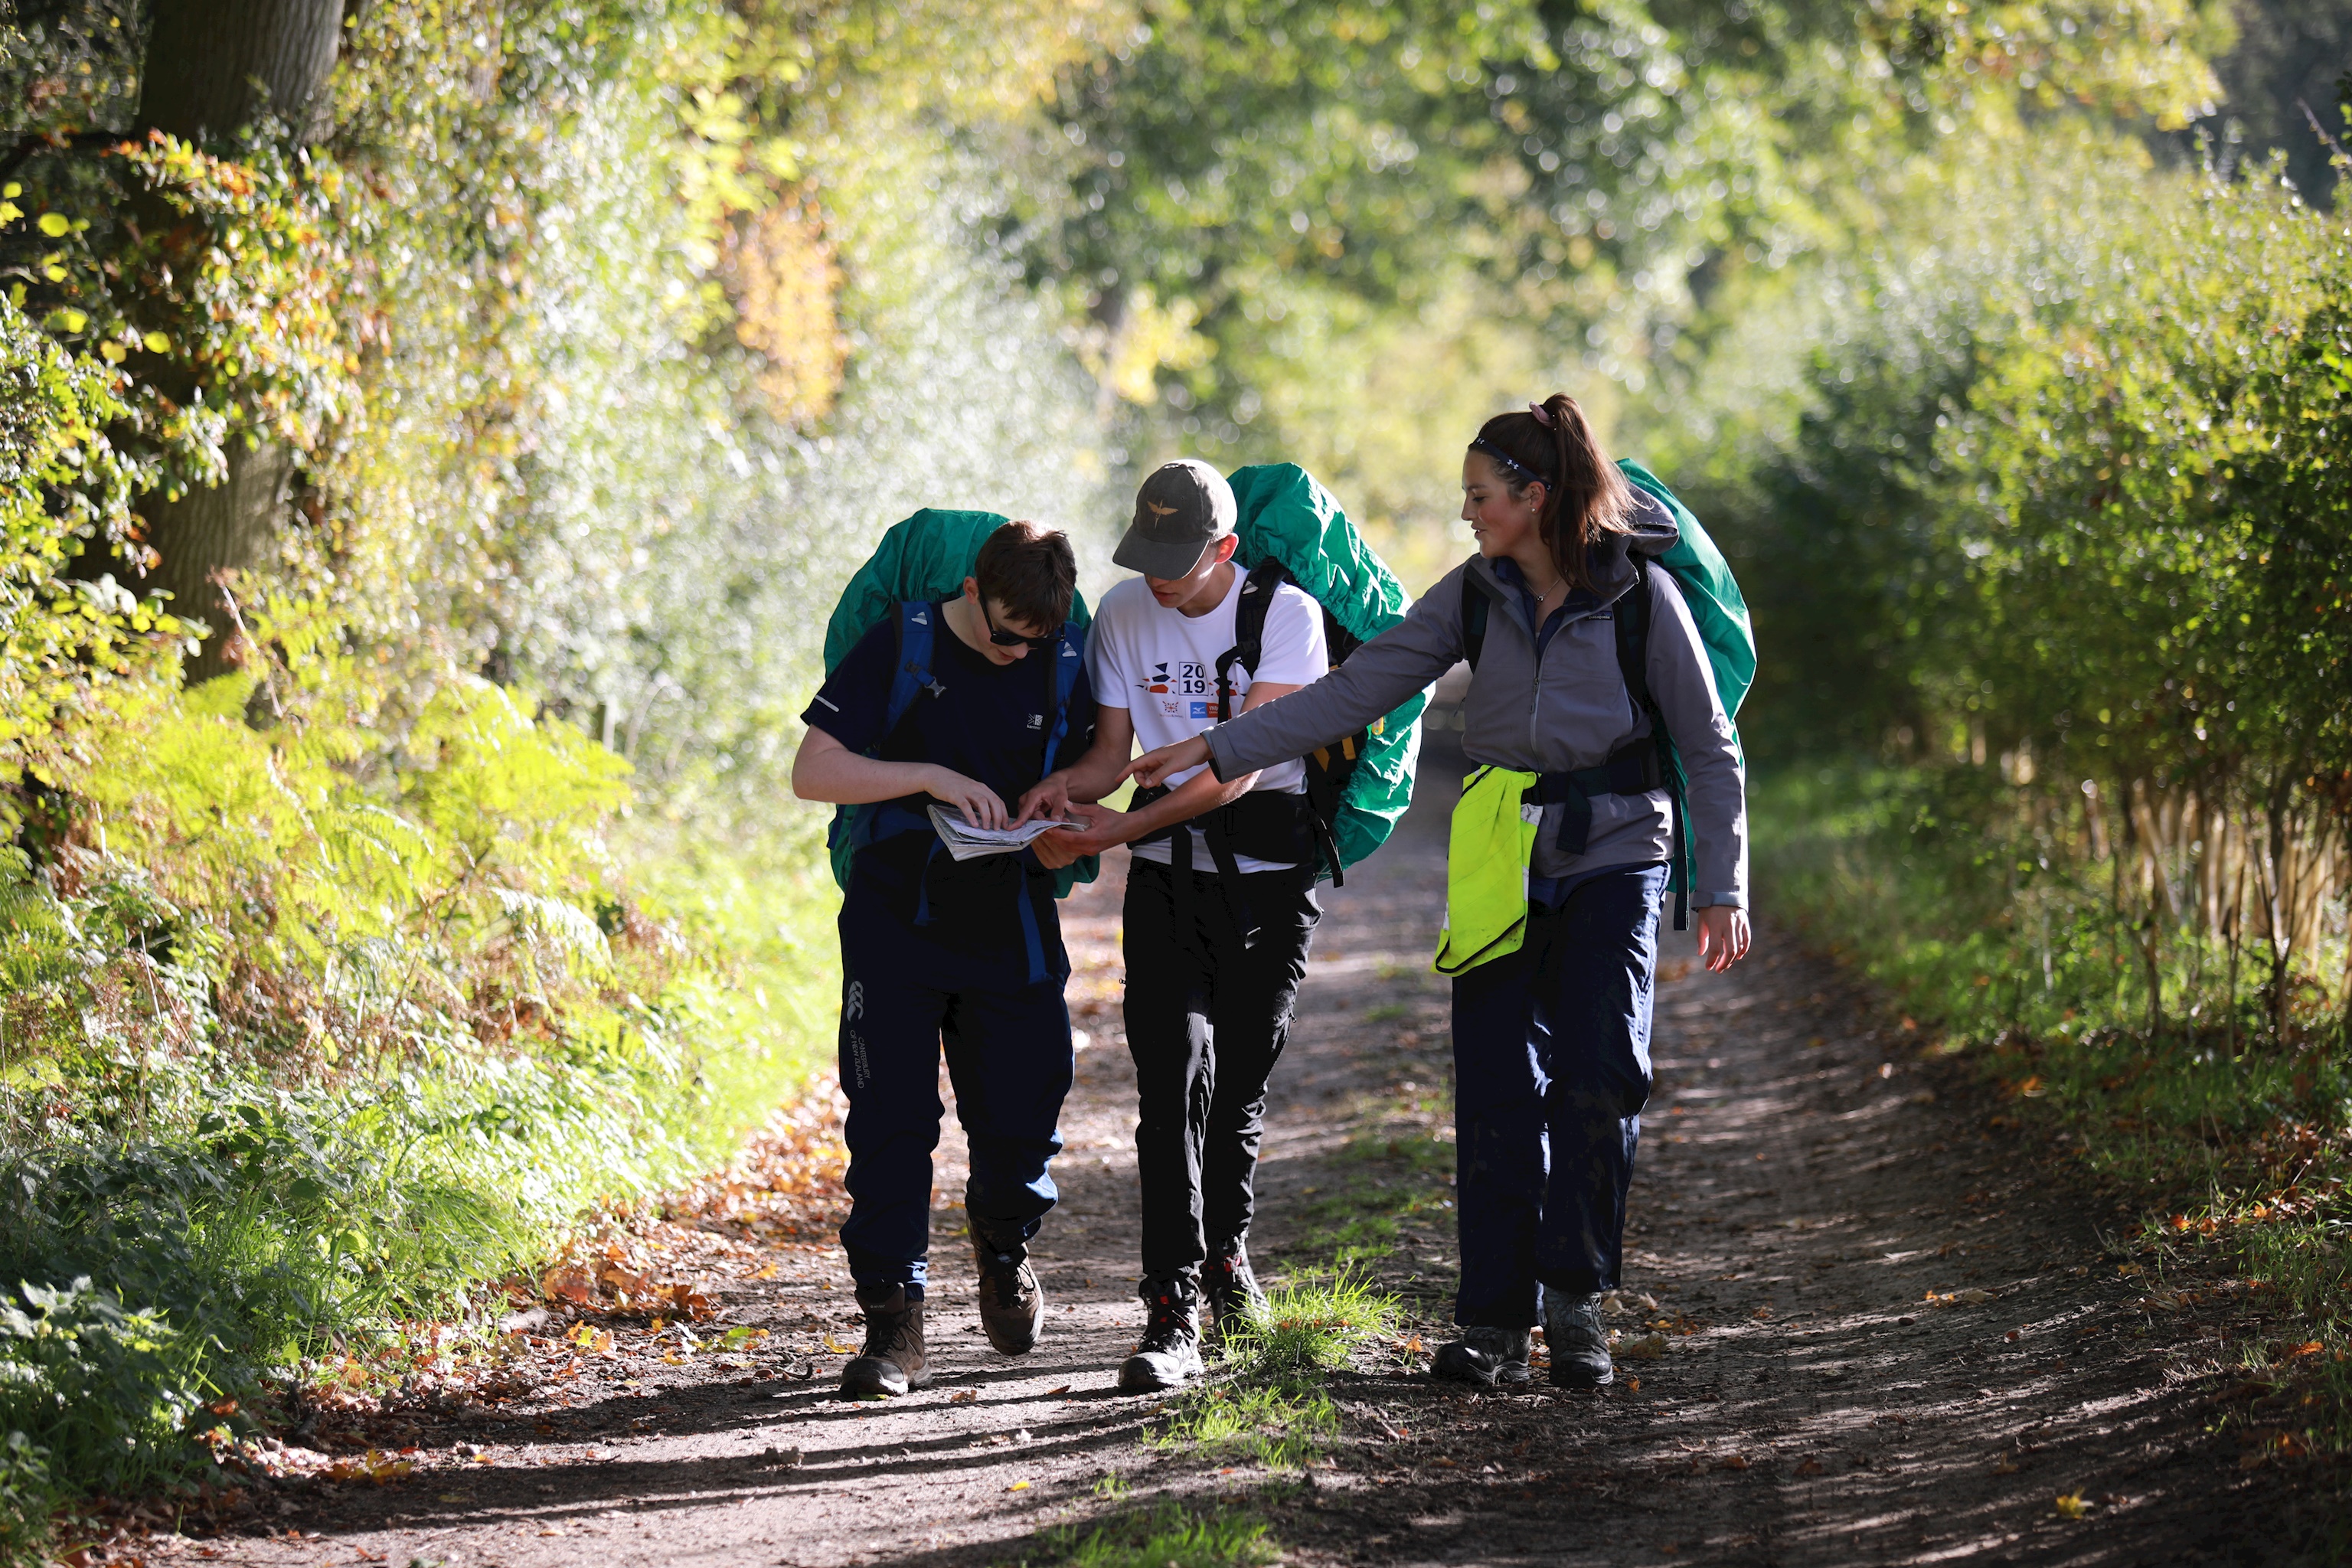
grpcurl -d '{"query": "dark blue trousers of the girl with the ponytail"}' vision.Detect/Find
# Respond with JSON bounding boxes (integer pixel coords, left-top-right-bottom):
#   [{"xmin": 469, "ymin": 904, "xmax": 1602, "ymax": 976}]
[{"xmin": 1453, "ymin": 865, "xmax": 1665, "ymax": 1328}]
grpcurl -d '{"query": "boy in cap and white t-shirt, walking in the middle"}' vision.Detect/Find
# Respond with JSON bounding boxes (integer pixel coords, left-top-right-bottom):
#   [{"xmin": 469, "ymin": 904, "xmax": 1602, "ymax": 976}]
[{"xmin": 1021, "ymin": 459, "xmax": 1329, "ymax": 1392}]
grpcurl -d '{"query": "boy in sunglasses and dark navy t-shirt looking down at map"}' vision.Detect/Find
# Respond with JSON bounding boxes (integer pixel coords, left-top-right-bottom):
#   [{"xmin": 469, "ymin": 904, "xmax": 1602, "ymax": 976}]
[{"xmin": 792, "ymin": 522, "xmax": 1093, "ymax": 1394}]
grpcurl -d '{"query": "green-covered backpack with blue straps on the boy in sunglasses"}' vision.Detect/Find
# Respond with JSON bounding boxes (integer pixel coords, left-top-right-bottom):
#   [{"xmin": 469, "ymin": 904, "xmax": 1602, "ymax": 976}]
[{"xmin": 825, "ymin": 508, "xmax": 1099, "ymax": 912}]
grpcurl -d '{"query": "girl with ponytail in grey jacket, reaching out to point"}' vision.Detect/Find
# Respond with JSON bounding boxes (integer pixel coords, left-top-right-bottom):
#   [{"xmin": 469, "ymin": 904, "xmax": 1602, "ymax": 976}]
[{"xmin": 1129, "ymin": 393, "xmax": 1747, "ymax": 1387}]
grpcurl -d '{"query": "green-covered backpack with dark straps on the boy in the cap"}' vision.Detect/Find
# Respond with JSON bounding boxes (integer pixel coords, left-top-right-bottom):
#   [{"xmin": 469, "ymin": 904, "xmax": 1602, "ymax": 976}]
[{"xmin": 1216, "ymin": 463, "xmax": 1428, "ymax": 887}]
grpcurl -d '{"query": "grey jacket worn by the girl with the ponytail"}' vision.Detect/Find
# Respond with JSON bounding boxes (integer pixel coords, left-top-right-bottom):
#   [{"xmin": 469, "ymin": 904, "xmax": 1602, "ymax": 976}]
[{"xmin": 1207, "ymin": 503, "xmax": 1747, "ymax": 907}]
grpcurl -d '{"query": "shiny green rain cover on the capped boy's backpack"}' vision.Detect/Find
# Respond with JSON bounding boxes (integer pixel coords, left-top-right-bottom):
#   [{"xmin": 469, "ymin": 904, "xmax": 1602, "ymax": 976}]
[{"xmin": 1228, "ymin": 463, "xmax": 1430, "ymax": 884}]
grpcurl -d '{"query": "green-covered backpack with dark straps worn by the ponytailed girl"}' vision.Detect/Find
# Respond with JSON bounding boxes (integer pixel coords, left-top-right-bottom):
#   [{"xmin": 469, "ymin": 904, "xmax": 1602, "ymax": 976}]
[{"xmin": 1463, "ymin": 459, "xmax": 1757, "ymax": 931}]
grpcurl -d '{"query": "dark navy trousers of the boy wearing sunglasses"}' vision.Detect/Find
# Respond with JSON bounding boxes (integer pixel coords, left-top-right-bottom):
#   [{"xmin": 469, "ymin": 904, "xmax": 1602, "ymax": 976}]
[{"xmin": 840, "ymin": 877, "xmax": 1075, "ymax": 1295}]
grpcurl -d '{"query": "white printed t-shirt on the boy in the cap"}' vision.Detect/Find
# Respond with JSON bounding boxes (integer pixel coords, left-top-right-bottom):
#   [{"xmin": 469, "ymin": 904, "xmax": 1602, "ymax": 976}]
[{"xmin": 1086, "ymin": 567, "xmax": 1331, "ymax": 872}]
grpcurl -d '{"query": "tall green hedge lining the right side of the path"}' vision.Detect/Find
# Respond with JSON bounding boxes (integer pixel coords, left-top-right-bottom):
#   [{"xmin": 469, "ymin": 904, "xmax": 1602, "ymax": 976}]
[{"xmin": 1750, "ymin": 139, "xmax": 2352, "ymax": 1034}]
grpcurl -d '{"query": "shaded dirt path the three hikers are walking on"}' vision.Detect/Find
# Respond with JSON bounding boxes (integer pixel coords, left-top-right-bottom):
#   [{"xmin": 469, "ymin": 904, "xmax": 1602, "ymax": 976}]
[{"xmin": 170, "ymin": 738, "xmax": 2288, "ymax": 1568}]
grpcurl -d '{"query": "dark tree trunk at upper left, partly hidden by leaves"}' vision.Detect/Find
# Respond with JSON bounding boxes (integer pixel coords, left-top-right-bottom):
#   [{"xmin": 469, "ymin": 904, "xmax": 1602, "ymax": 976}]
[{"xmin": 139, "ymin": 0, "xmax": 344, "ymax": 684}]
